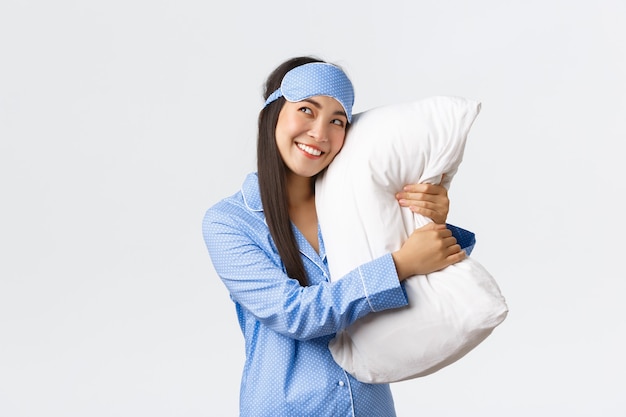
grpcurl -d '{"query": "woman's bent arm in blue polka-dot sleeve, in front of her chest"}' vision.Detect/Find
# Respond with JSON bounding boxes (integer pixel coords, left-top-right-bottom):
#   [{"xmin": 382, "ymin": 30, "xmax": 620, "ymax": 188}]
[{"xmin": 203, "ymin": 204, "xmax": 407, "ymax": 339}]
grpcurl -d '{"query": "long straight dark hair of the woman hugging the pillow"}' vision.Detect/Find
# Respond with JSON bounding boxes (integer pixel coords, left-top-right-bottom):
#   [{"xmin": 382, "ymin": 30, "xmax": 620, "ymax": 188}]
[{"xmin": 257, "ymin": 56, "xmax": 324, "ymax": 286}]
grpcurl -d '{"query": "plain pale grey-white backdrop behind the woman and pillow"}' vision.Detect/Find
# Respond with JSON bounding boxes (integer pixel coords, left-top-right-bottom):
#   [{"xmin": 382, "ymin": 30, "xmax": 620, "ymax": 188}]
[{"xmin": 0, "ymin": 0, "xmax": 626, "ymax": 417}]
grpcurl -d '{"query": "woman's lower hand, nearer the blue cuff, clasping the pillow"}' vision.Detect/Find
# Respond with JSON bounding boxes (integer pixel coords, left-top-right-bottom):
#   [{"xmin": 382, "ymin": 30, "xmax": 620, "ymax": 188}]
[{"xmin": 391, "ymin": 223, "xmax": 467, "ymax": 281}]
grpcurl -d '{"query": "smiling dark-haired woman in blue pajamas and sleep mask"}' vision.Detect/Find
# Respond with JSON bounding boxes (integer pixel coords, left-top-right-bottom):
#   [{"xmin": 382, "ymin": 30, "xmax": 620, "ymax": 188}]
[{"xmin": 203, "ymin": 57, "xmax": 466, "ymax": 417}]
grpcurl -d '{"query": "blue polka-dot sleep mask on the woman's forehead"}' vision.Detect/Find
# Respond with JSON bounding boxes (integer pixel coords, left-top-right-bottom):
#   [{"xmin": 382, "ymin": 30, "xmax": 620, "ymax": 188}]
[{"xmin": 264, "ymin": 62, "xmax": 354, "ymax": 122}]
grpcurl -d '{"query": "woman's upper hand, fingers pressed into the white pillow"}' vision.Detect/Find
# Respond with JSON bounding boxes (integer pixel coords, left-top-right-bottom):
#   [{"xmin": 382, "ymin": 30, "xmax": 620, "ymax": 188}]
[{"xmin": 396, "ymin": 179, "xmax": 450, "ymax": 224}]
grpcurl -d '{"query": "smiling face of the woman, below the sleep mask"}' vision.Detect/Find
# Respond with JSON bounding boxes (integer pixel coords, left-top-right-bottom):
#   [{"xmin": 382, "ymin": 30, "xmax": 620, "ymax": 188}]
[{"xmin": 276, "ymin": 96, "xmax": 348, "ymax": 177}]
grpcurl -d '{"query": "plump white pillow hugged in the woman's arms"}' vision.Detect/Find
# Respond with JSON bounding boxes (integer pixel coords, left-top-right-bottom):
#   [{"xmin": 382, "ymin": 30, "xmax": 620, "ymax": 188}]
[{"xmin": 316, "ymin": 96, "xmax": 508, "ymax": 383}]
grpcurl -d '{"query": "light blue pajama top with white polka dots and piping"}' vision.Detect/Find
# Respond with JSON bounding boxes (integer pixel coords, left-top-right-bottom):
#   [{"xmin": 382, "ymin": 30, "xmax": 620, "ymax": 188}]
[{"xmin": 202, "ymin": 173, "xmax": 474, "ymax": 417}]
